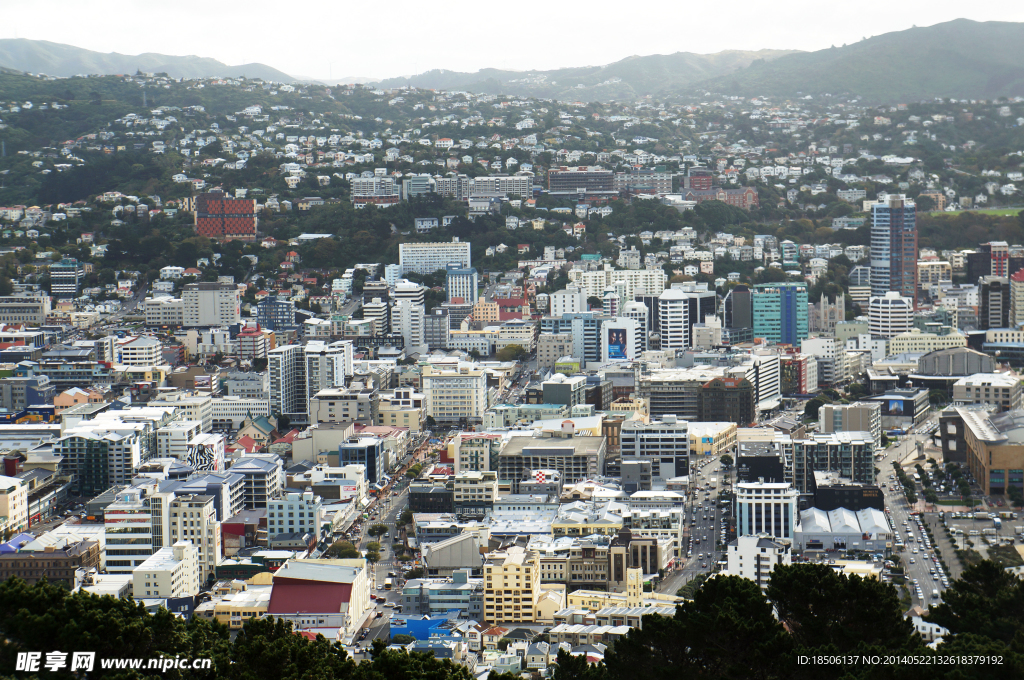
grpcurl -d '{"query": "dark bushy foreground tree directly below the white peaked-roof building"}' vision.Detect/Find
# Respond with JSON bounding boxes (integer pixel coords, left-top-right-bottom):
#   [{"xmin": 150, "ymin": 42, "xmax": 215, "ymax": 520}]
[{"xmin": 767, "ymin": 563, "xmax": 922, "ymax": 653}]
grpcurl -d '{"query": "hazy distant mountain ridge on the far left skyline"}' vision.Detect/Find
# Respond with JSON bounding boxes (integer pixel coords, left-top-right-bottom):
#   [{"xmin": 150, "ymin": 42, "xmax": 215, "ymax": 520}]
[{"xmin": 0, "ymin": 38, "xmax": 297, "ymax": 83}]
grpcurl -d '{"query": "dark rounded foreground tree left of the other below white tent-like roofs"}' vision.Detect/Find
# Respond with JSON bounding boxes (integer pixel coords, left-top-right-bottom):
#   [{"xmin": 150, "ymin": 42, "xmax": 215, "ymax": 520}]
[{"xmin": 604, "ymin": 576, "xmax": 793, "ymax": 680}]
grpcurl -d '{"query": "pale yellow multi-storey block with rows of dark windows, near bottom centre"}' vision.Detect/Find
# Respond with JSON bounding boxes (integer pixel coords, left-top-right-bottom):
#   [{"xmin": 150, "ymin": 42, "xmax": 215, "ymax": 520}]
[{"xmin": 483, "ymin": 546, "xmax": 542, "ymax": 624}]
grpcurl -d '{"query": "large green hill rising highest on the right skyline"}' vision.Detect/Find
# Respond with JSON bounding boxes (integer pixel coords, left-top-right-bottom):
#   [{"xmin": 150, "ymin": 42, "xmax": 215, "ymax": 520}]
[{"xmin": 697, "ymin": 19, "xmax": 1024, "ymax": 102}]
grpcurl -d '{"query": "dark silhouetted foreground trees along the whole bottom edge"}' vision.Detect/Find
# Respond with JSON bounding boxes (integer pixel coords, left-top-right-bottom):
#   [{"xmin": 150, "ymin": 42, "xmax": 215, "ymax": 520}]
[{"xmin": 0, "ymin": 561, "xmax": 1024, "ymax": 680}]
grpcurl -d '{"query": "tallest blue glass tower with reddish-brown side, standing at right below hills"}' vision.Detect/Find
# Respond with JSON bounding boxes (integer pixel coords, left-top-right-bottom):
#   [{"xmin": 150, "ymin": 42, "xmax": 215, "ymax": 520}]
[{"xmin": 871, "ymin": 195, "xmax": 918, "ymax": 306}]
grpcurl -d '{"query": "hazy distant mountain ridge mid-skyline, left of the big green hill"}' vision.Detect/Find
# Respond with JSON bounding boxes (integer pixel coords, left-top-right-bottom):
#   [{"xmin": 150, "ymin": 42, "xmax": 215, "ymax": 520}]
[{"xmin": 378, "ymin": 50, "xmax": 792, "ymax": 101}]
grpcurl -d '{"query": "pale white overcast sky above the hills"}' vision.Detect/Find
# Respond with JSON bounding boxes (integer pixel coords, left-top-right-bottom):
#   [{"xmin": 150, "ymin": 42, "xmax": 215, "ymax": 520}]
[{"xmin": 0, "ymin": 0, "xmax": 1024, "ymax": 79}]
